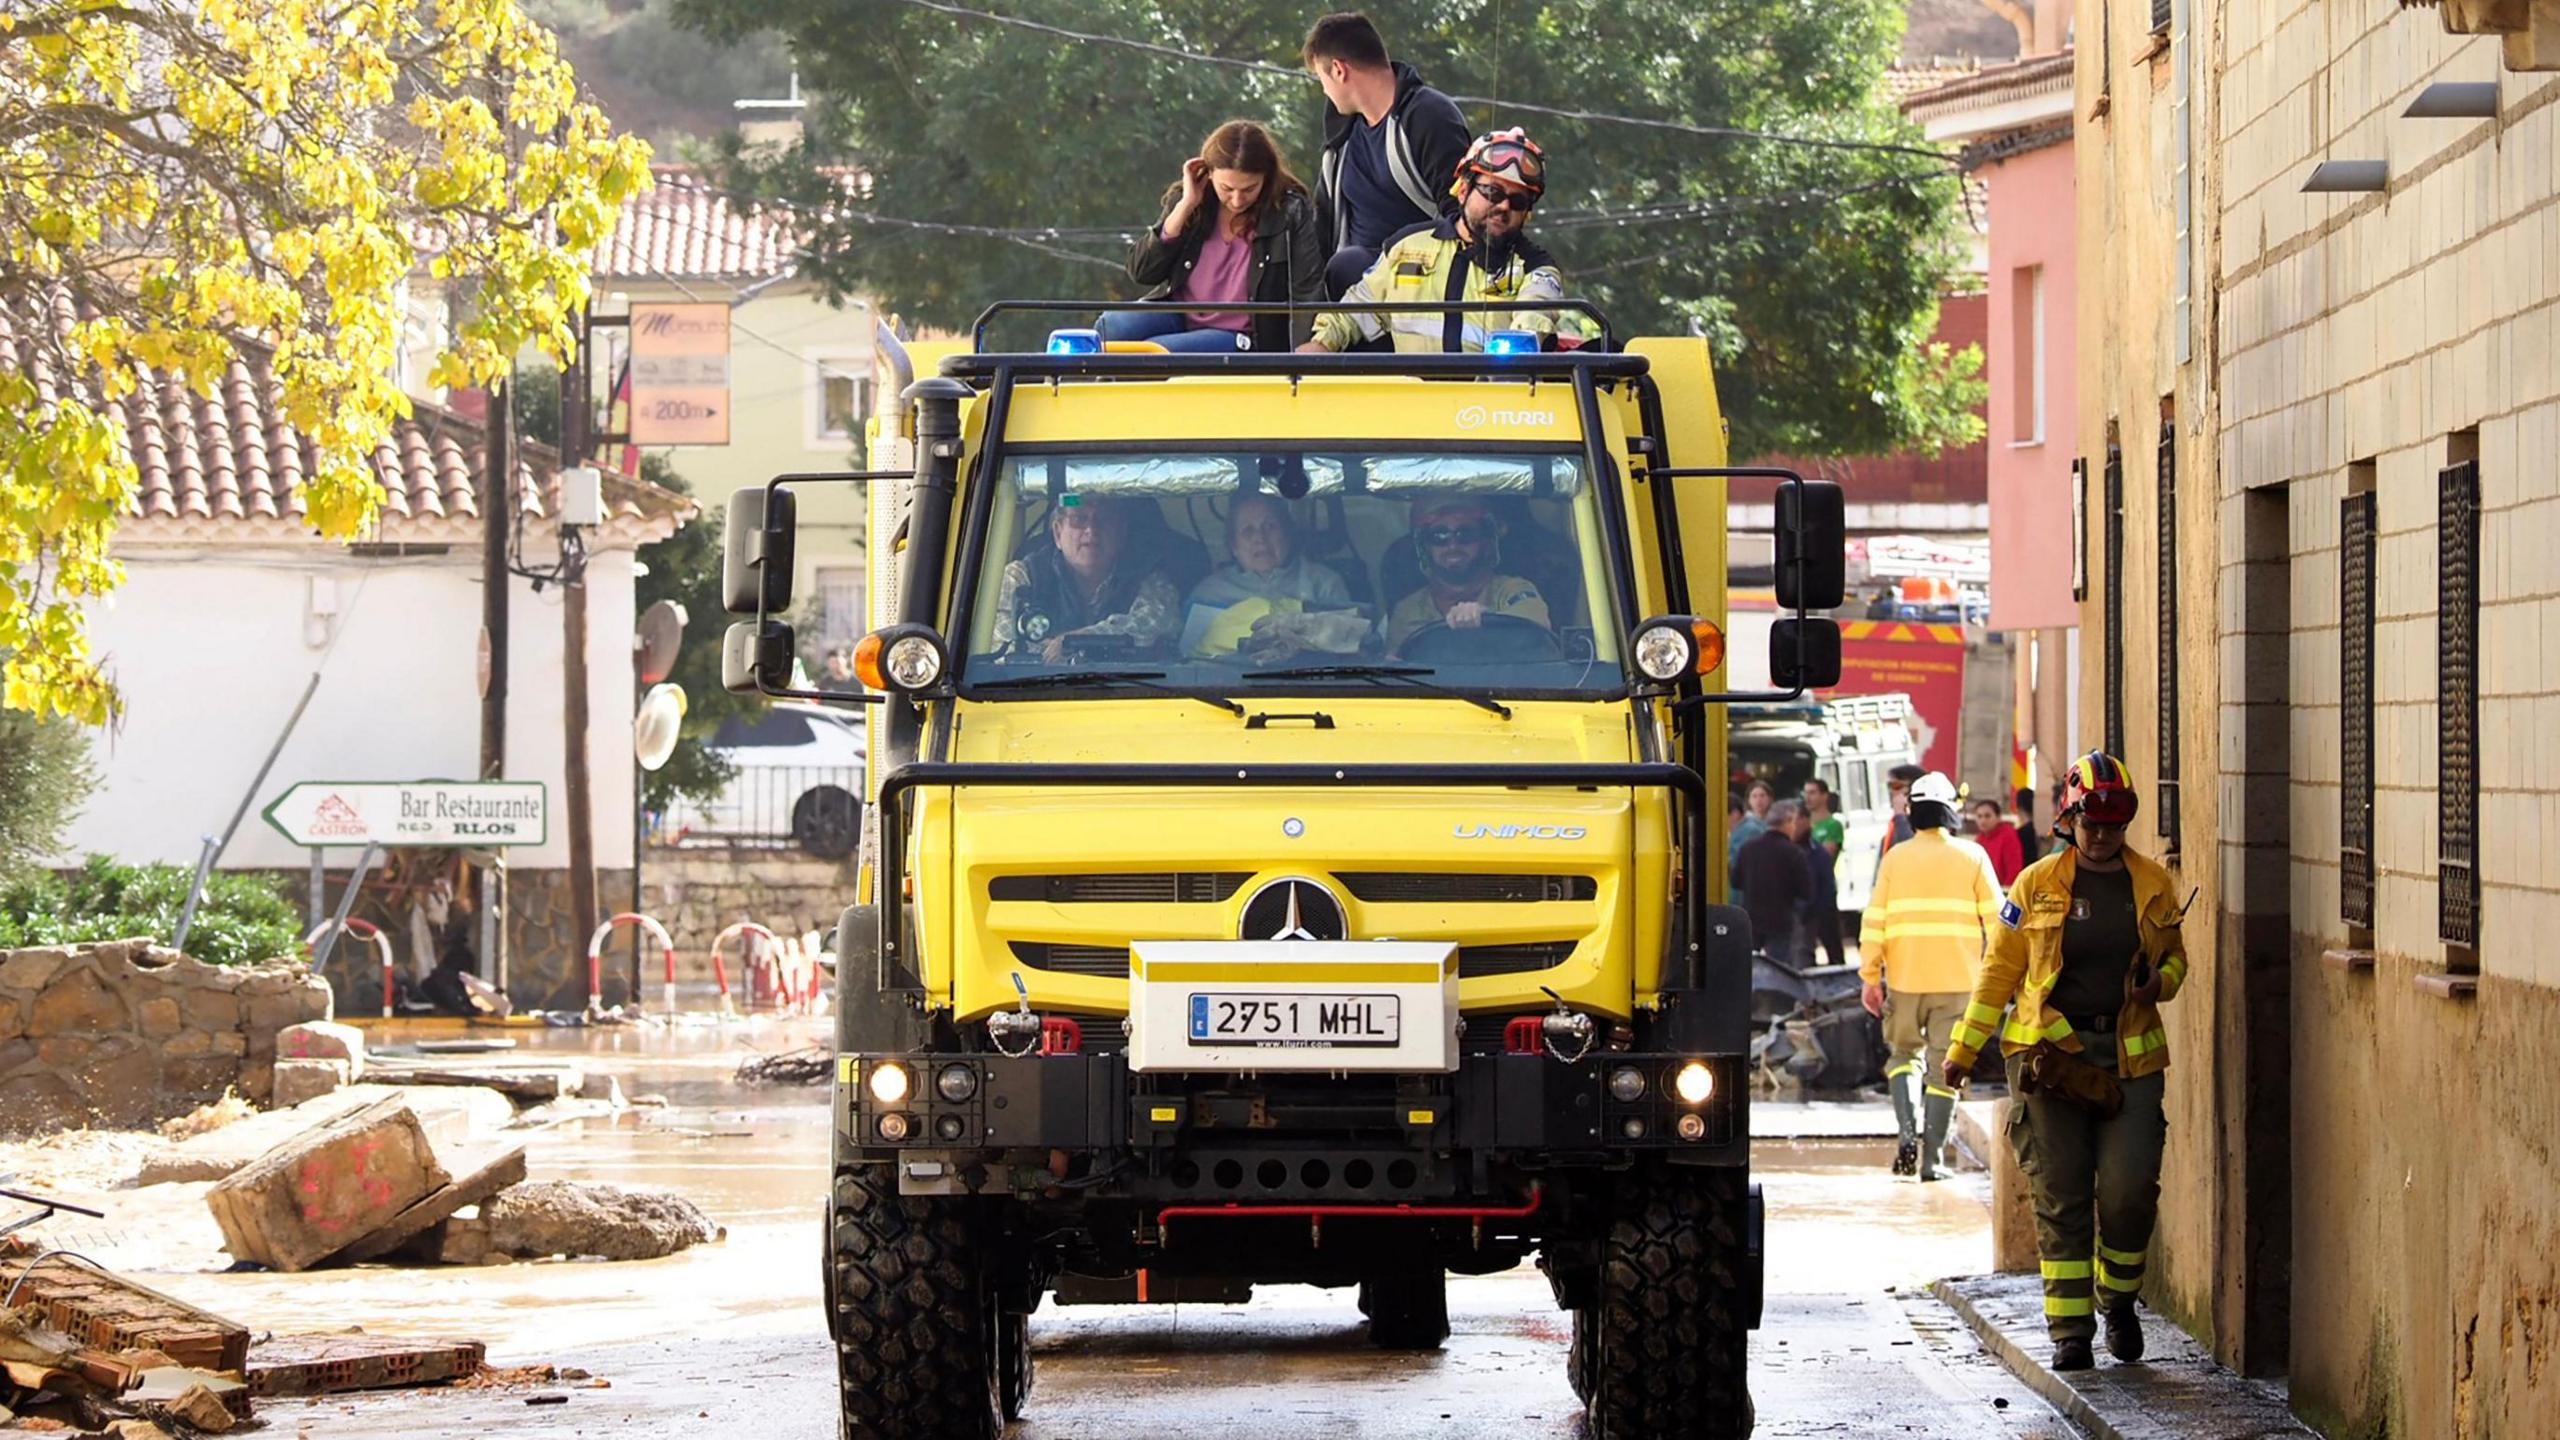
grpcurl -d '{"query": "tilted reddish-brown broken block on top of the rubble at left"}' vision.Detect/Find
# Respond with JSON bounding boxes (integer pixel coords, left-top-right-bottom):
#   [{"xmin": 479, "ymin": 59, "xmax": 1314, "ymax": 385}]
[{"xmin": 205, "ymin": 1097, "xmax": 453, "ymax": 1271}]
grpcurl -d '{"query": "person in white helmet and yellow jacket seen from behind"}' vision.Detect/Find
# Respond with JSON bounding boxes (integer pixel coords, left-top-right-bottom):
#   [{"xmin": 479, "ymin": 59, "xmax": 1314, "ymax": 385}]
[{"xmin": 1859, "ymin": 771, "xmax": 2002, "ymax": 1181}]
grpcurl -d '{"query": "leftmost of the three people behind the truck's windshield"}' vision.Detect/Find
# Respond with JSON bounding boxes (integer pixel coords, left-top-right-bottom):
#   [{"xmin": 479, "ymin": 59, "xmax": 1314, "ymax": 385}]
[{"xmin": 996, "ymin": 495, "xmax": 1183, "ymax": 666}]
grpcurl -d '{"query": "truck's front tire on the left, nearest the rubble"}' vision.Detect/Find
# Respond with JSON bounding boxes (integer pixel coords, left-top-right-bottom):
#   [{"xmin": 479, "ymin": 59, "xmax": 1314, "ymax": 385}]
[{"xmin": 827, "ymin": 1166, "xmax": 1003, "ymax": 1440}]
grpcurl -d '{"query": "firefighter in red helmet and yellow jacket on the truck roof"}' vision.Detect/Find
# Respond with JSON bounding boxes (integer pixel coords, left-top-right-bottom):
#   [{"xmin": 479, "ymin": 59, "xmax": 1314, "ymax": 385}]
[{"xmin": 1298, "ymin": 128, "xmax": 1564, "ymax": 354}]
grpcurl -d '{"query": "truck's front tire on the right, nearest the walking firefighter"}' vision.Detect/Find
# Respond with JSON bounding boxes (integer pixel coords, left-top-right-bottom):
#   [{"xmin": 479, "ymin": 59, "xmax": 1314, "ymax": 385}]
[{"xmin": 1590, "ymin": 1166, "xmax": 1751, "ymax": 1440}]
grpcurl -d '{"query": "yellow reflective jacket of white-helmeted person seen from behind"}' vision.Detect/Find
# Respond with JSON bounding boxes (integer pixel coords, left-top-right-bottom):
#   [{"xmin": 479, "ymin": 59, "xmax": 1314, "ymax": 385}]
[{"xmin": 1859, "ymin": 830, "xmax": 1999, "ymax": 994}]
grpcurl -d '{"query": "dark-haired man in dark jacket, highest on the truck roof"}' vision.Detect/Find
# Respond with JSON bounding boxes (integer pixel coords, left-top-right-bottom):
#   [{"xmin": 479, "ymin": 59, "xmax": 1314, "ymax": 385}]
[{"xmin": 1298, "ymin": 10, "xmax": 1467, "ymax": 300}]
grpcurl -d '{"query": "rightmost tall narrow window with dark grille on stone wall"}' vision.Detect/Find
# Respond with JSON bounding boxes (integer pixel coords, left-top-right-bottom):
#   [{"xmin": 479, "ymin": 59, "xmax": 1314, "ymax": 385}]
[{"xmin": 2435, "ymin": 459, "xmax": 2481, "ymax": 948}]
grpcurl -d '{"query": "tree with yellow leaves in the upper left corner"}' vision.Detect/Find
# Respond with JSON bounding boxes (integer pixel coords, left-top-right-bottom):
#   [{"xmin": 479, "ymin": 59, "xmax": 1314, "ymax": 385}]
[{"xmin": 0, "ymin": 0, "xmax": 648, "ymax": 723}]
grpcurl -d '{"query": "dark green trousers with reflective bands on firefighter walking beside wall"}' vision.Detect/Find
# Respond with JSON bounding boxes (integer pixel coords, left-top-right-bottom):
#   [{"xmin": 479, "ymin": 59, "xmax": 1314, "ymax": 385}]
[{"xmin": 2007, "ymin": 1035, "xmax": 2168, "ymax": 1340}]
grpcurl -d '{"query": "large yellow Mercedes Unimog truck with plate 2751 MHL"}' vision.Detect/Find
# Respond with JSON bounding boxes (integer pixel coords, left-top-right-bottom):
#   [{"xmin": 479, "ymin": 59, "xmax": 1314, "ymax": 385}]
[{"xmin": 724, "ymin": 302, "xmax": 1843, "ymax": 1440}]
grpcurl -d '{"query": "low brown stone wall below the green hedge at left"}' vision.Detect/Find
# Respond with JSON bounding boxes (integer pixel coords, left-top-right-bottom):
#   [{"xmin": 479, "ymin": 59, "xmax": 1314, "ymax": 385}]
[{"xmin": 0, "ymin": 940, "xmax": 330, "ymax": 1135}]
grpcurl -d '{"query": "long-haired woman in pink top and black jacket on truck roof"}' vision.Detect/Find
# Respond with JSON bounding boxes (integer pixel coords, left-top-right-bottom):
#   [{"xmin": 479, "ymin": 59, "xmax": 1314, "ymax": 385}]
[{"xmin": 1101, "ymin": 120, "xmax": 1326, "ymax": 354}]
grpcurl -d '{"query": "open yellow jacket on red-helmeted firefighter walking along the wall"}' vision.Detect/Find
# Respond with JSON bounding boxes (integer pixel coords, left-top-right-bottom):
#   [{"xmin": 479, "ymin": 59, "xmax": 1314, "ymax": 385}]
[{"xmin": 1945, "ymin": 840, "xmax": 2186, "ymax": 1079}]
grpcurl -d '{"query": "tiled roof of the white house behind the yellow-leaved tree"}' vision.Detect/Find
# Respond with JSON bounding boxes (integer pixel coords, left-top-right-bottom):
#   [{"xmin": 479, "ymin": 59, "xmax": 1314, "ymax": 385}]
[{"xmin": 0, "ymin": 292, "xmax": 694, "ymax": 541}]
